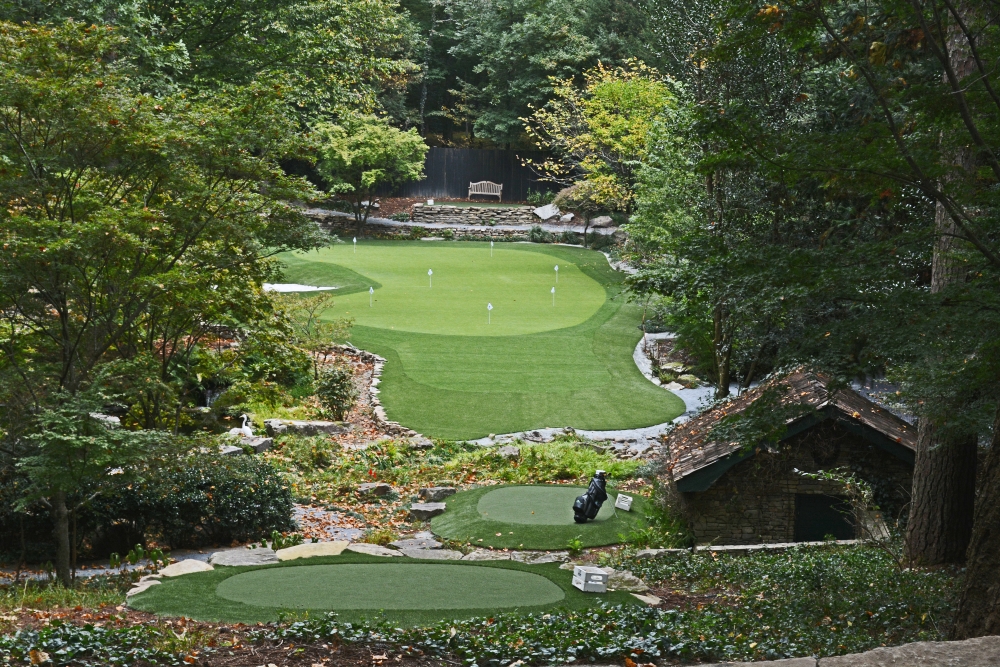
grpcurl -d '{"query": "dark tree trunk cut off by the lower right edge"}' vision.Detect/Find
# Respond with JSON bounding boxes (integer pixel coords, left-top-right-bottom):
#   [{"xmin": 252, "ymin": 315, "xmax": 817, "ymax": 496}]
[{"xmin": 952, "ymin": 405, "xmax": 1000, "ymax": 639}]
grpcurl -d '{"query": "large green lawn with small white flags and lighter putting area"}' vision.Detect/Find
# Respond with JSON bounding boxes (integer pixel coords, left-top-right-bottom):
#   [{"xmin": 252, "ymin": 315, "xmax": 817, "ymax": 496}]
[{"xmin": 282, "ymin": 240, "xmax": 684, "ymax": 439}]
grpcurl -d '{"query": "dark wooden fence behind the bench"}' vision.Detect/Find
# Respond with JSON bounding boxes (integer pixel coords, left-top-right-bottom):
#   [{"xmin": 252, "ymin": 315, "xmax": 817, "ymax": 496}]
[{"xmin": 378, "ymin": 148, "xmax": 555, "ymax": 202}]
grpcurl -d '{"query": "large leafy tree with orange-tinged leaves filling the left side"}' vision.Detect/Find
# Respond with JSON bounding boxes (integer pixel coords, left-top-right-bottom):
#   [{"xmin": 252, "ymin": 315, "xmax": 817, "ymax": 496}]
[{"xmin": 0, "ymin": 23, "xmax": 321, "ymax": 583}]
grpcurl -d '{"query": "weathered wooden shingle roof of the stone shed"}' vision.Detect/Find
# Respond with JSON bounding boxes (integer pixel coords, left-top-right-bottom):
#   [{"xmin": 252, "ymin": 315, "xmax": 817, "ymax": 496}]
[{"xmin": 666, "ymin": 368, "xmax": 917, "ymax": 490}]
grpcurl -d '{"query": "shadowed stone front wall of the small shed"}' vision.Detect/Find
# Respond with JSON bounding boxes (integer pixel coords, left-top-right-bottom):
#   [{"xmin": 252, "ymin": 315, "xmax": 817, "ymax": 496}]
[{"xmin": 683, "ymin": 420, "xmax": 913, "ymax": 544}]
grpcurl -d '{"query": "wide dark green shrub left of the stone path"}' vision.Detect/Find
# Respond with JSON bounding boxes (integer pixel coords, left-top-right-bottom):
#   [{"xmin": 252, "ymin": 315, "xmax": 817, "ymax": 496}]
[{"xmin": 91, "ymin": 454, "xmax": 294, "ymax": 548}]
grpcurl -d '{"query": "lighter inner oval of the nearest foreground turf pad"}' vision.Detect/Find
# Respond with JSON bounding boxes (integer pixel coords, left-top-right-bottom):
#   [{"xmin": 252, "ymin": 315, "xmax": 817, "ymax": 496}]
[{"xmin": 215, "ymin": 563, "xmax": 566, "ymax": 611}]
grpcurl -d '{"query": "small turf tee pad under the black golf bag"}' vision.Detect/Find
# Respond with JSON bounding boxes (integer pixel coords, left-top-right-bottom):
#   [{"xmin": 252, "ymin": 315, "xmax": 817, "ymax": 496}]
[{"xmin": 431, "ymin": 485, "xmax": 646, "ymax": 549}]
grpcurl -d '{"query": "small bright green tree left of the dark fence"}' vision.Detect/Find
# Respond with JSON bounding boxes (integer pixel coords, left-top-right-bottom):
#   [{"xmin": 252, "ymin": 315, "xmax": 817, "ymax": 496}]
[{"xmin": 315, "ymin": 116, "xmax": 427, "ymax": 227}]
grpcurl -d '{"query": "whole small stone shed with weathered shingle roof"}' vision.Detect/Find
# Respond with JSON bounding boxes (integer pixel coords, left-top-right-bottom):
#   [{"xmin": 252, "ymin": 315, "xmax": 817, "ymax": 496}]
[{"xmin": 664, "ymin": 368, "xmax": 917, "ymax": 544}]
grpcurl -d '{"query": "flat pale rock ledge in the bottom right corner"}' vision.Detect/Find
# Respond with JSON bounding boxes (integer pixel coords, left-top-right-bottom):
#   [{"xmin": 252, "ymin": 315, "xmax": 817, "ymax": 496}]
[{"xmin": 816, "ymin": 636, "xmax": 1000, "ymax": 667}]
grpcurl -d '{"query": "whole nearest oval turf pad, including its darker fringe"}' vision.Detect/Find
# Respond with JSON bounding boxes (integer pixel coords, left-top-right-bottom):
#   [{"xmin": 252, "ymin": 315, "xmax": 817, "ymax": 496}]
[{"xmin": 129, "ymin": 552, "xmax": 638, "ymax": 626}]
